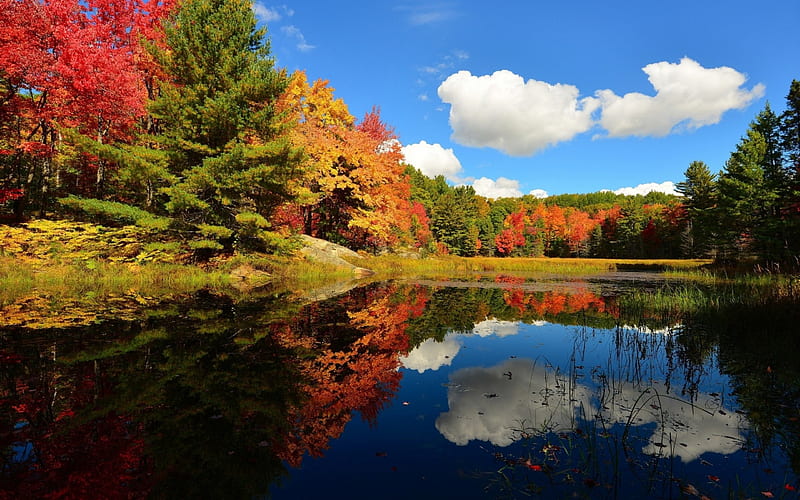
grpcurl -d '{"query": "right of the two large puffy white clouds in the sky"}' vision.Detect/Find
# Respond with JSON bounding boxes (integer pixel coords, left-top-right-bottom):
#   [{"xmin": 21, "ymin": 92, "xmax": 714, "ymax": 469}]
[{"xmin": 596, "ymin": 57, "xmax": 764, "ymax": 137}]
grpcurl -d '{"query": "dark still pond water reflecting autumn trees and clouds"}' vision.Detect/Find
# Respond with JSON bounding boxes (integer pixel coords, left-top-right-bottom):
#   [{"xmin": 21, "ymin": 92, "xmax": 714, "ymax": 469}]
[{"xmin": 0, "ymin": 276, "xmax": 800, "ymax": 499}]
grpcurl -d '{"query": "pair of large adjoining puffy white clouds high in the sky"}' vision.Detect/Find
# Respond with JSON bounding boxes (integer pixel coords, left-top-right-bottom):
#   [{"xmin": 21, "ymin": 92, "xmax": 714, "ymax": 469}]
[{"xmin": 438, "ymin": 57, "xmax": 764, "ymax": 156}]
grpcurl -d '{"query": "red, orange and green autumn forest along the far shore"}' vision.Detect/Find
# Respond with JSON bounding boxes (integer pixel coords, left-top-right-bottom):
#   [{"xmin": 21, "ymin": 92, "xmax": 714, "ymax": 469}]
[{"xmin": 0, "ymin": 0, "xmax": 800, "ymax": 264}]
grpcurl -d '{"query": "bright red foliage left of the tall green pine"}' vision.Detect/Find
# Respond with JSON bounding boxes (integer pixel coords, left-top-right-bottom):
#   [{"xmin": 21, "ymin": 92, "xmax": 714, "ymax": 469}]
[{"xmin": 0, "ymin": 0, "xmax": 168, "ymax": 143}]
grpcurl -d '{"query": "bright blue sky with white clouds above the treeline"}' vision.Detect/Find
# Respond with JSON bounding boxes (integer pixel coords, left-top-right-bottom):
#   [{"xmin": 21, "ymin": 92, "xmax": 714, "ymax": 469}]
[{"xmin": 254, "ymin": 0, "xmax": 800, "ymax": 197}]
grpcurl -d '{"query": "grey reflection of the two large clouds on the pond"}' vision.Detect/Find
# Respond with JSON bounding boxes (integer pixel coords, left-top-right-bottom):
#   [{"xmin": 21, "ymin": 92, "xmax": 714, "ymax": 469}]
[{"xmin": 436, "ymin": 359, "xmax": 745, "ymax": 462}]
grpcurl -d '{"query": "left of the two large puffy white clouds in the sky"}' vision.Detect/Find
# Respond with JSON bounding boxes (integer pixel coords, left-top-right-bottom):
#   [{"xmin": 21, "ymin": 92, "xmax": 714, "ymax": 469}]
[{"xmin": 438, "ymin": 70, "xmax": 599, "ymax": 156}]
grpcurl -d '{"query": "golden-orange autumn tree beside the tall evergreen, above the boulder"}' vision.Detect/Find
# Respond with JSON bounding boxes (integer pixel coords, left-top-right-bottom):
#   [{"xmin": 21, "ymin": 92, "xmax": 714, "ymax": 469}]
[{"xmin": 280, "ymin": 72, "xmax": 411, "ymax": 248}]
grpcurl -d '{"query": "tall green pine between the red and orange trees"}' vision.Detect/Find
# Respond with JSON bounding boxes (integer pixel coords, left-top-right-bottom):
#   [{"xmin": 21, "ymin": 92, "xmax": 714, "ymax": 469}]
[{"xmin": 151, "ymin": 0, "xmax": 299, "ymax": 227}]
